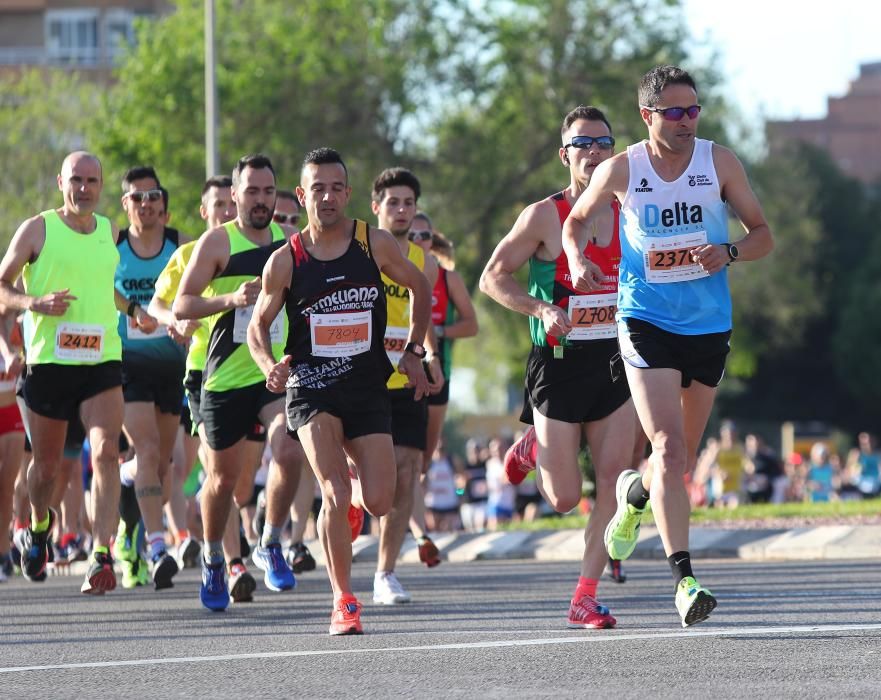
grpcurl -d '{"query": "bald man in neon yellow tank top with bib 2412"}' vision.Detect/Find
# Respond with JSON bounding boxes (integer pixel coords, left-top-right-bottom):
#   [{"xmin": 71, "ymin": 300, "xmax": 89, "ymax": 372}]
[{"xmin": 0, "ymin": 151, "xmax": 152, "ymax": 594}]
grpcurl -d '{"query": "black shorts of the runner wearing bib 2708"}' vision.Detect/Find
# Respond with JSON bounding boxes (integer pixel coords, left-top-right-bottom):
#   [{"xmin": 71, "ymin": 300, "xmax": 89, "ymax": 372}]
[{"xmin": 520, "ymin": 339, "xmax": 630, "ymax": 423}]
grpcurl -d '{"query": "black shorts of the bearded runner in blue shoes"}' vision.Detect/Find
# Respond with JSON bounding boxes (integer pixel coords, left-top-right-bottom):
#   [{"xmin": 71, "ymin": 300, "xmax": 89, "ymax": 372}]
[{"xmin": 199, "ymin": 382, "xmax": 284, "ymax": 450}]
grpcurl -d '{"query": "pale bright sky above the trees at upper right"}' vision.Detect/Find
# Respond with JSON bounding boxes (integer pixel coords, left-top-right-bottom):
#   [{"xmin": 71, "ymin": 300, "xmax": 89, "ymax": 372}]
[{"xmin": 683, "ymin": 0, "xmax": 881, "ymax": 119}]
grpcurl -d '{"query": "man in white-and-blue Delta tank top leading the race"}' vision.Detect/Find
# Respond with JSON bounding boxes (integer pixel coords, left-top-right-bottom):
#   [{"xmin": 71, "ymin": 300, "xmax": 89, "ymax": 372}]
[{"xmin": 563, "ymin": 66, "xmax": 773, "ymax": 627}]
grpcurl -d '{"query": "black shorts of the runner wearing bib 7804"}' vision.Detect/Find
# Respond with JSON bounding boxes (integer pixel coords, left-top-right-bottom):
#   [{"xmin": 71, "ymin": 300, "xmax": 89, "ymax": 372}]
[{"xmin": 287, "ymin": 381, "xmax": 392, "ymax": 440}]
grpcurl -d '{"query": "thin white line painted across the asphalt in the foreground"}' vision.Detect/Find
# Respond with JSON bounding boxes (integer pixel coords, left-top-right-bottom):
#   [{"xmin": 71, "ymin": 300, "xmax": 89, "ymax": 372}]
[{"xmin": 0, "ymin": 624, "xmax": 881, "ymax": 674}]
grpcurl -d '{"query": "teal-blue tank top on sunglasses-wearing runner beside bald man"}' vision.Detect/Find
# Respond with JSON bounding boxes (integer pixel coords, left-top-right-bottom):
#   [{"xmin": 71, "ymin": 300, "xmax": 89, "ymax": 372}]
[{"xmin": 114, "ymin": 228, "xmax": 186, "ymax": 363}]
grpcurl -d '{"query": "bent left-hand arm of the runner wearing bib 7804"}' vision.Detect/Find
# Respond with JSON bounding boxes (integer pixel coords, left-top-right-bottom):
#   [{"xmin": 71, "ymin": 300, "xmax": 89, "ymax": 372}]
[{"xmin": 248, "ymin": 246, "xmax": 294, "ymax": 393}]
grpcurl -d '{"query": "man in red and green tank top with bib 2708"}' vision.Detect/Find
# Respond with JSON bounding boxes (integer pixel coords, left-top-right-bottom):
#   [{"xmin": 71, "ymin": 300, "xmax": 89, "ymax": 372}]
[{"xmin": 480, "ymin": 105, "xmax": 636, "ymax": 629}]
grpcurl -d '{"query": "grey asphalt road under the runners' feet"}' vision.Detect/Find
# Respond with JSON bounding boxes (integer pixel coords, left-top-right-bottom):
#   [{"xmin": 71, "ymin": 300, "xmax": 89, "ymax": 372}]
[{"xmin": 0, "ymin": 560, "xmax": 881, "ymax": 700}]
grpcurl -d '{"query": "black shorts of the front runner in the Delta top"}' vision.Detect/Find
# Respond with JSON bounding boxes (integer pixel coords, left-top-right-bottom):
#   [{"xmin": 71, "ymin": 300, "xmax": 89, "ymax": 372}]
[{"xmin": 618, "ymin": 318, "xmax": 731, "ymax": 388}]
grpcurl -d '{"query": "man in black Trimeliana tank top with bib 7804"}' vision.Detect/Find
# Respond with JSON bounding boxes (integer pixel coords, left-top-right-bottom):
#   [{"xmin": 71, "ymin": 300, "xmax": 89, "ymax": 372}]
[{"xmin": 248, "ymin": 148, "xmax": 431, "ymax": 635}]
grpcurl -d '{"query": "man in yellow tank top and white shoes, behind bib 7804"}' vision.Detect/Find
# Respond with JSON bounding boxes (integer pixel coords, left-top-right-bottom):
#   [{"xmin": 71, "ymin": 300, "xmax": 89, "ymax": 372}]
[{"xmin": 372, "ymin": 168, "xmax": 444, "ymax": 605}]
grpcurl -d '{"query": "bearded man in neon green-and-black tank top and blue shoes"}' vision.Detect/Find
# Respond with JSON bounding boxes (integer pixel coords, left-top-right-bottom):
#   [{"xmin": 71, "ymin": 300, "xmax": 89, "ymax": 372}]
[{"xmin": 173, "ymin": 155, "xmax": 305, "ymax": 610}]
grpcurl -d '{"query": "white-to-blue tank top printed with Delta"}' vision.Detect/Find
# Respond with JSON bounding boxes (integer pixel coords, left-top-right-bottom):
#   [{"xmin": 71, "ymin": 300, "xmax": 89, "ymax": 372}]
[{"xmin": 617, "ymin": 139, "xmax": 731, "ymax": 335}]
